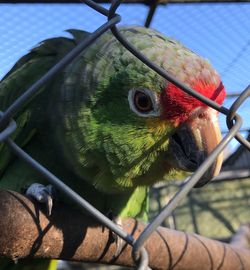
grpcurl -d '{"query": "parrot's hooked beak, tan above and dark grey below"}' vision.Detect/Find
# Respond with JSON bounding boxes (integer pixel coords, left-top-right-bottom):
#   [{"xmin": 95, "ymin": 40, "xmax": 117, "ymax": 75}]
[{"xmin": 169, "ymin": 107, "xmax": 223, "ymax": 187}]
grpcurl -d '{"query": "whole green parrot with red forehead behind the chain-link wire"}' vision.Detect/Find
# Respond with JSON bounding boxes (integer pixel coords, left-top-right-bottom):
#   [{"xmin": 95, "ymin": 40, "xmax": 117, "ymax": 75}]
[{"xmin": 0, "ymin": 26, "xmax": 226, "ymax": 269}]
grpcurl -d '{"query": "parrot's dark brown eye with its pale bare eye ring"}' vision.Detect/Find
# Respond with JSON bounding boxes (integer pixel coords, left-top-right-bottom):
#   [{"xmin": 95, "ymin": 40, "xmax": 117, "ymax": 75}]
[{"xmin": 128, "ymin": 88, "xmax": 159, "ymax": 117}]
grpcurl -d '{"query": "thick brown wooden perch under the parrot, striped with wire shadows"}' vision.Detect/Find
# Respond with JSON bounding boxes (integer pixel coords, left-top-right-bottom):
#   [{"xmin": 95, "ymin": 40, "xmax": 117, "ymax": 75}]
[{"xmin": 0, "ymin": 190, "xmax": 250, "ymax": 270}]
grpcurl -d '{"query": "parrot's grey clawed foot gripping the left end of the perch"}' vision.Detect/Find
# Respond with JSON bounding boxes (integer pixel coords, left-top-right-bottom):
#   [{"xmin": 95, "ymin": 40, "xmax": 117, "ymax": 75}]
[{"xmin": 26, "ymin": 183, "xmax": 55, "ymax": 216}]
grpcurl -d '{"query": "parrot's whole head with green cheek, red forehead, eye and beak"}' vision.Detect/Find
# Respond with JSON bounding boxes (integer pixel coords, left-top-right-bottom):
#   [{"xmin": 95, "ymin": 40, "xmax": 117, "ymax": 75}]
[{"xmin": 61, "ymin": 27, "xmax": 225, "ymax": 191}]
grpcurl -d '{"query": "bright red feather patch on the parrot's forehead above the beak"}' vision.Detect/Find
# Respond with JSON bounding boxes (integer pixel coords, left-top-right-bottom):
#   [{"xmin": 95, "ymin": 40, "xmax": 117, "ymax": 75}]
[{"xmin": 160, "ymin": 81, "xmax": 226, "ymax": 124}]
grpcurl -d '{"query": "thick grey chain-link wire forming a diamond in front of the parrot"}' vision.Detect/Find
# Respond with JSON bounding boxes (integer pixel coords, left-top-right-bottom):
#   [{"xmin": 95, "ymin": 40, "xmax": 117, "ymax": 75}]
[{"xmin": 0, "ymin": 0, "xmax": 250, "ymax": 269}]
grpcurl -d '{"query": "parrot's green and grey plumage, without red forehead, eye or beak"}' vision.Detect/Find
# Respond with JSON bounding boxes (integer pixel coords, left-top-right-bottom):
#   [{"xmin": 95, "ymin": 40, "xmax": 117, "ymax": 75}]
[{"xmin": 0, "ymin": 24, "xmax": 222, "ymax": 268}]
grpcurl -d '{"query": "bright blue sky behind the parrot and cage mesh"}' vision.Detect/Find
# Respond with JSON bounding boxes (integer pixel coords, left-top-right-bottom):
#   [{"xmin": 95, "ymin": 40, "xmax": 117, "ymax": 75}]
[{"xmin": 0, "ymin": 3, "xmax": 250, "ymax": 153}]
